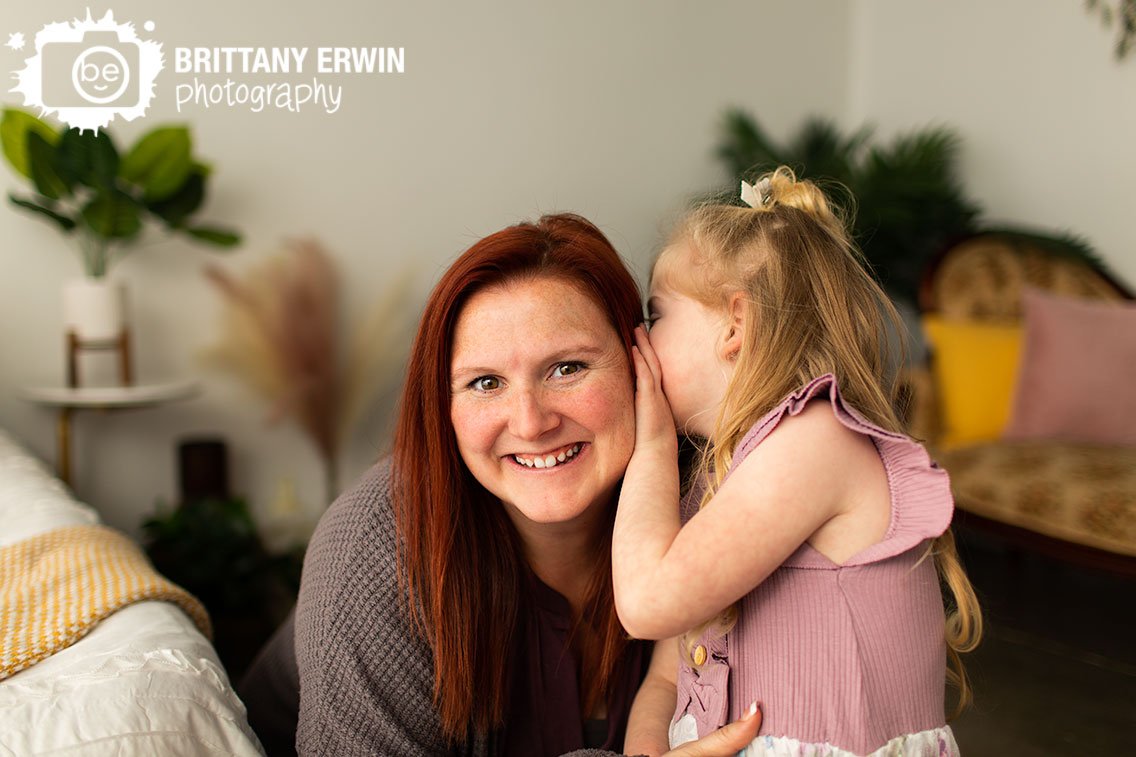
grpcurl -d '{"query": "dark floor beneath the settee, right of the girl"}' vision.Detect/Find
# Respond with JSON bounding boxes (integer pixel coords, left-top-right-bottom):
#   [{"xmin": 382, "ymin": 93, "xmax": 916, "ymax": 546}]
[{"xmin": 952, "ymin": 531, "xmax": 1136, "ymax": 757}]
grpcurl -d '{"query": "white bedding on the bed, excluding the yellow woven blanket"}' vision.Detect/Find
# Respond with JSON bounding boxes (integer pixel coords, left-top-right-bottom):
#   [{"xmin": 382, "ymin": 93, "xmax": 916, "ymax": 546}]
[{"xmin": 0, "ymin": 431, "xmax": 264, "ymax": 757}]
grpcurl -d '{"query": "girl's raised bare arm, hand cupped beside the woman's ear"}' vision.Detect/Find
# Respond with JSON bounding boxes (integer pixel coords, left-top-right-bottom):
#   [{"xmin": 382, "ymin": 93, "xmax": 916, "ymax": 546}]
[{"xmin": 611, "ymin": 328, "xmax": 870, "ymax": 639}]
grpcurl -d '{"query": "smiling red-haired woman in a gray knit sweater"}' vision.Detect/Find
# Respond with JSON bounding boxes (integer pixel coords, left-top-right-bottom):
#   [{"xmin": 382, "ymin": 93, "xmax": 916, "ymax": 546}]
[{"xmin": 240, "ymin": 215, "xmax": 757, "ymax": 756}]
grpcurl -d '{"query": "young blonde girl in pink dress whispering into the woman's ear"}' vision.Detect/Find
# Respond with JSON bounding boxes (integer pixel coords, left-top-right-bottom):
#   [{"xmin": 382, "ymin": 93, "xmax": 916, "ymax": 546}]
[{"xmin": 612, "ymin": 167, "xmax": 982, "ymax": 757}]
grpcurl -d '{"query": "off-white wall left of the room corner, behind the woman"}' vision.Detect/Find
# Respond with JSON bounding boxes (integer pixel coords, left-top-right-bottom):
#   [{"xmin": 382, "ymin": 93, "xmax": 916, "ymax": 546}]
[{"xmin": 0, "ymin": 0, "xmax": 854, "ymax": 531}]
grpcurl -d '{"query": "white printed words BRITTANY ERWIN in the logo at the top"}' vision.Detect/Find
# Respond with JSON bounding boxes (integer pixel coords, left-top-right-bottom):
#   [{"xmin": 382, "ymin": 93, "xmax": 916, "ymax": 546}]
[{"xmin": 174, "ymin": 48, "xmax": 407, "ymax": 74}]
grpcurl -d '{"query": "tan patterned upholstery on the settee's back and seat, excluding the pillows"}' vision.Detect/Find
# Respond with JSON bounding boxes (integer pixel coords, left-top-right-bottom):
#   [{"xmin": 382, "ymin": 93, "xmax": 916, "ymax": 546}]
[{"xmin": 908, "ymin": 235, "xmax": 1136, "ymax": 557}]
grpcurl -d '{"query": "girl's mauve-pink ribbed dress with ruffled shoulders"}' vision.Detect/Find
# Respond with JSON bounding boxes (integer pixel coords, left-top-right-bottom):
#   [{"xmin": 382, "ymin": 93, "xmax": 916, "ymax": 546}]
[{"xmin": 670, "ymin": 374, "xmax": 959, "ymax": 757}]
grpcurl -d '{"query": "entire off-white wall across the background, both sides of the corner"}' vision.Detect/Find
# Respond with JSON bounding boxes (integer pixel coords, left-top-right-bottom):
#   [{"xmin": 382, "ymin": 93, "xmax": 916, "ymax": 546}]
[{"xmin": 13, "ymin": 0, "xmax": 1136, "ymax": 543}]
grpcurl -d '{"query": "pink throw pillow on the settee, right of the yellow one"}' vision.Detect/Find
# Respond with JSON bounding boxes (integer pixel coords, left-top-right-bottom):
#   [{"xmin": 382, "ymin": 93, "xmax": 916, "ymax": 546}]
[{"xmin": 1003, "ymin": 288, "xmax": 1136, "ymax": 444}]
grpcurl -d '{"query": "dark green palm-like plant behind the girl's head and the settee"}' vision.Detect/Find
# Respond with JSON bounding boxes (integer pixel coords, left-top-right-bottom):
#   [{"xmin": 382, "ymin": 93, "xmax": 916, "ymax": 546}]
[{"xmin": 718, "ymin": 109, "xmax": 1106, "ymax": 302}]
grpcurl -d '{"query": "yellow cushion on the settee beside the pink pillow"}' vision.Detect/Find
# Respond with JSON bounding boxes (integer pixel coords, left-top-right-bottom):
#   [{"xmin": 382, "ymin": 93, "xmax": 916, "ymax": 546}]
[{"xmin": 922, "ymin": 316, "xmax": 1021, "ymax": 448}]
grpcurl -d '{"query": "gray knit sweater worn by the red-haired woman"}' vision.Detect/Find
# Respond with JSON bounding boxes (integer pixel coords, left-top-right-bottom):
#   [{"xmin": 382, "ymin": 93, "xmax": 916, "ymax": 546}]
[{"xmin": 295, "ymin": 461, "xmax": 640, "ymax": 757}]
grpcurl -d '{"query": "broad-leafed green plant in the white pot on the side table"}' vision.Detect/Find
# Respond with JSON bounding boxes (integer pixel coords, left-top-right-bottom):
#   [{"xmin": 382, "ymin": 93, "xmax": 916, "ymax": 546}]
[{"xmin": 0, "ymin": 108, "xmax": 241, "ymax": 278}]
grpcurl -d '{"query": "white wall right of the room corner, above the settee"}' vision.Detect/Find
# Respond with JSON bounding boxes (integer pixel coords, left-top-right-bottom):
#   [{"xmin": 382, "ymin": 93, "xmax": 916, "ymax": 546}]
[{"xmin": 849, "ymin": 0, "xmax": 1136, "ymax": 284}]
